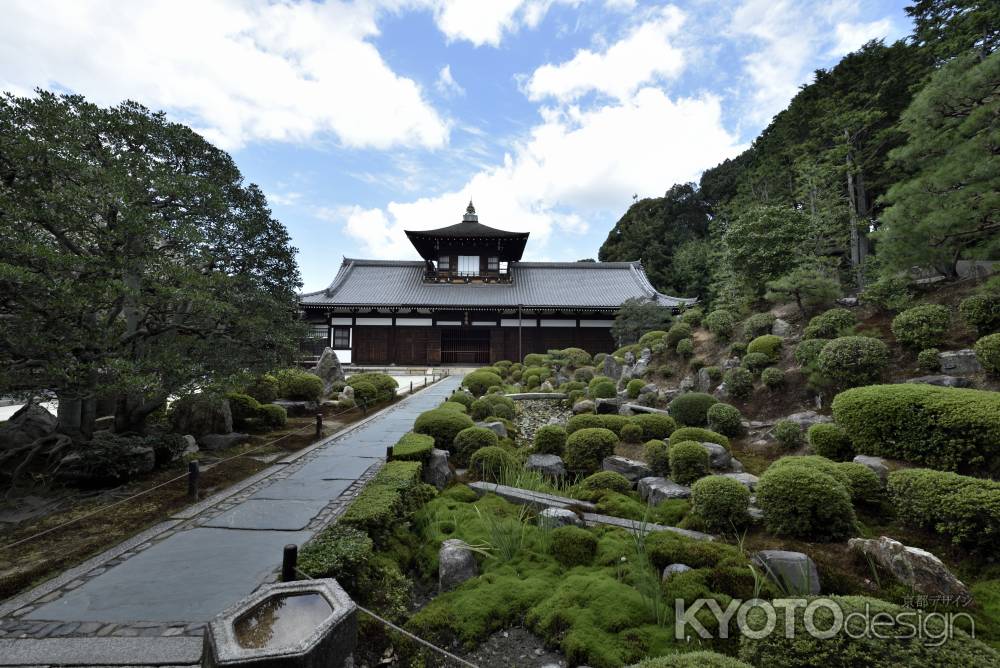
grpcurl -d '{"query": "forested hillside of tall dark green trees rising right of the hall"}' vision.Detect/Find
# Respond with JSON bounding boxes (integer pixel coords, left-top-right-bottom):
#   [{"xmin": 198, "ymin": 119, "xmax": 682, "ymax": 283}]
[{"xmin": 599, "ymin": 0, "xmax": 1000, "ymax": 307}]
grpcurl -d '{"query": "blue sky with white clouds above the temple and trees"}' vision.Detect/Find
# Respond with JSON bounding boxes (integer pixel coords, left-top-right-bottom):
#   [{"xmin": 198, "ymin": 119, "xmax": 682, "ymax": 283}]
[{"xmin": 0, "ymin": 0, "xmax": 910, "ymax": 289}]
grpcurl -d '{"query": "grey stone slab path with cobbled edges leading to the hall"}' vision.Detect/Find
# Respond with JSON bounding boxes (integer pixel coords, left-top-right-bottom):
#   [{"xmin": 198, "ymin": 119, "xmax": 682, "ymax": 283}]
[{"xmin": 0, "ymin": 376, "xmax": 461, "ymax": 665}]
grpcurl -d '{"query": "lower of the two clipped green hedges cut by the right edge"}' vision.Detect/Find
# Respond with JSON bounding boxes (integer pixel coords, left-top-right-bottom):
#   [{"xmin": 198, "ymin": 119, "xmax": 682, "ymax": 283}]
[{"xmin": 887, "ymin": 469, "xmax": 1000, "ymax": 555}]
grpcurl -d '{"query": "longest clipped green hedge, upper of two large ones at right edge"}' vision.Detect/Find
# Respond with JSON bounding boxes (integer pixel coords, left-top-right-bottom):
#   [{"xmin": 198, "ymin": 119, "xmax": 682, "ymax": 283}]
[{"xmin": 833, "ymin": 383, "xmax": 1000, "ymax": 472}]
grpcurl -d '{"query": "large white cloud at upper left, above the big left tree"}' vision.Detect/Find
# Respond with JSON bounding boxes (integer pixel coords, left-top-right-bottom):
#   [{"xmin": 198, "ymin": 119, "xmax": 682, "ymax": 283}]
[{"xmin": 0, "ymin": 0, "xmax": 449, "ymax": 148}]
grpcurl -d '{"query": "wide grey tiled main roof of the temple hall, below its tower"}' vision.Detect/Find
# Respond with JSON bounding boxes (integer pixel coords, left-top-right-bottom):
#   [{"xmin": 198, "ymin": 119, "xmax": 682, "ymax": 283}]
[{"xmin": 299, "ymin": 258, "xmax": 697, "ymax": 309}]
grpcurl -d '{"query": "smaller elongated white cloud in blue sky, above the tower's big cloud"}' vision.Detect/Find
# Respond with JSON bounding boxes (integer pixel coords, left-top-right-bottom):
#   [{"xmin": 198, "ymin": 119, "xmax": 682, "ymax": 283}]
[{"xmin": 526, "ymin": 5, "xmax": 684, "ymax": 102}]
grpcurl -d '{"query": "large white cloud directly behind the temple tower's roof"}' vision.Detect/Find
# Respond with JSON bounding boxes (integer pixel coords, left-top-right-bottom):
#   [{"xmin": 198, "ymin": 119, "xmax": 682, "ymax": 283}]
[{"xmin": 334, "ymin": 88, "xmax": 742, "ymax": 259}]
